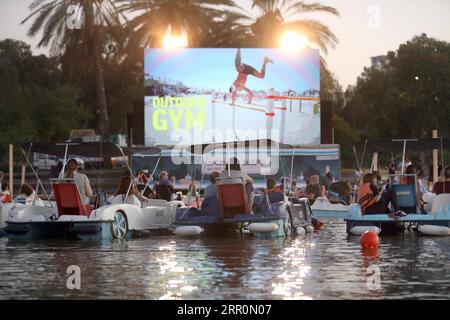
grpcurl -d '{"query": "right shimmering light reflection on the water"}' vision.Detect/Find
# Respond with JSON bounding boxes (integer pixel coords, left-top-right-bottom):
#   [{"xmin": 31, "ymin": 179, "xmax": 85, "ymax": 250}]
[{"xmin": 272, "ymin": 239, "xmax": 312, "ymax": 300}]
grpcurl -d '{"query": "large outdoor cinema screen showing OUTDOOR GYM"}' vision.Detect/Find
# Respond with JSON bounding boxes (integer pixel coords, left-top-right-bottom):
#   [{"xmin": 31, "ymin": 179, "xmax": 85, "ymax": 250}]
[{"xmin": 145, "ymin": 49, "xmax": 320, "ymax": 146}]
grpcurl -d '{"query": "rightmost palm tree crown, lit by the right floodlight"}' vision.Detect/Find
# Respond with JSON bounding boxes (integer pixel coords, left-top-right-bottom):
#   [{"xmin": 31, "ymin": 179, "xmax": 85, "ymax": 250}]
[{"xmin": 250, "ymin": 0, "xmax": 339, "ymax": 53}]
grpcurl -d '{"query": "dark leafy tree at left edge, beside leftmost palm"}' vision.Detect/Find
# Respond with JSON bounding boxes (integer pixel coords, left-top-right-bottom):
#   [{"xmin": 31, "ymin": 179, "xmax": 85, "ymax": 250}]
[{"xmin": 0, "ymin": 39, "xmax": 90, "ymax": 162}]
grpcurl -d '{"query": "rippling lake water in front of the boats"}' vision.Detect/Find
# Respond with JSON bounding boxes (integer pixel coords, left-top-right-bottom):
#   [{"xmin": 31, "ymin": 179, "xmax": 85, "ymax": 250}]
[{"xmin": 0, "ymin": 220, "xmax": 450, "ymax": 299}]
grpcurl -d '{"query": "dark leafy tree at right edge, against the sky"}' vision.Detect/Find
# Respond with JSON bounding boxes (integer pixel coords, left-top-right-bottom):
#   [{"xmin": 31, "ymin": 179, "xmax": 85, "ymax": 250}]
[{"xmin": 341, "ymin": 34, "xmax": 450, "ymax": 138}]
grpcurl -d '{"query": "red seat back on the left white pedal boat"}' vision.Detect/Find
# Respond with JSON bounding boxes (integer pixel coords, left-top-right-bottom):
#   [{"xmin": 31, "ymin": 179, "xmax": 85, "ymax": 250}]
[{"xmin": 52, "ymin": 180, "xmax": 92, "ymax": 217}]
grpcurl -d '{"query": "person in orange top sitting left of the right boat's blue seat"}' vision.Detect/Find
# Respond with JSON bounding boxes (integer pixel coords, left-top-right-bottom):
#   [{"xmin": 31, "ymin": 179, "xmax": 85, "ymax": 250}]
[{"xmin": 358, "ymin": 173, "xmax": 394, "ymax": 214}]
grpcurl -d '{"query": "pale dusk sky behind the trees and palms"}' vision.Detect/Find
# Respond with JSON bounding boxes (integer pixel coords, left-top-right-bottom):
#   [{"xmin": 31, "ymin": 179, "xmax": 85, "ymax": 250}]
[{"xmin": 0, "ymin": 0, "xmax": 450, "ymax": 88}]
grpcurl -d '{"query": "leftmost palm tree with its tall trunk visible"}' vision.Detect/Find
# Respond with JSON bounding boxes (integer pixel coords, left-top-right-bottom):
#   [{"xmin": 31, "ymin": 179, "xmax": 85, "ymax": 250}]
[{"xmin": 21, "ymin": 0, "xmax": 121, "ymax": 140}]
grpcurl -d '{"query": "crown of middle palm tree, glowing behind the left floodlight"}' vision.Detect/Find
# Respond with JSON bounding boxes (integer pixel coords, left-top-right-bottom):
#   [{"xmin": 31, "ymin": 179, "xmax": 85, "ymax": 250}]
[{"xmin": 117, "ymin": 0, "xmax": 237, "ymax": 47}]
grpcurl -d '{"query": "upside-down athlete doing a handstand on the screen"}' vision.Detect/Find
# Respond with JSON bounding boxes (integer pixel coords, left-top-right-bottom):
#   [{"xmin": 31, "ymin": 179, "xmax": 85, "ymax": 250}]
[{"xmin": 230, "ymin": 49, "xmax": 273, "ymax": 105}]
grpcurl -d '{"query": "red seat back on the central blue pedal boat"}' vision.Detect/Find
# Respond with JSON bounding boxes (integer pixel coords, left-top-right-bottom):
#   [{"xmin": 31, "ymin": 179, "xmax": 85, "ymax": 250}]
[{"xmin": 217, "ymin": 182, "xmax": 250, "ymax": 218}]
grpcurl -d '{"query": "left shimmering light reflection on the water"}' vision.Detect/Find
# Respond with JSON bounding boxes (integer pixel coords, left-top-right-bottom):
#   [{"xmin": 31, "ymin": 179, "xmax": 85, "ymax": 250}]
[{"xmin": 156, "ymin": 241, "xmax": 198, "ymax": 300}]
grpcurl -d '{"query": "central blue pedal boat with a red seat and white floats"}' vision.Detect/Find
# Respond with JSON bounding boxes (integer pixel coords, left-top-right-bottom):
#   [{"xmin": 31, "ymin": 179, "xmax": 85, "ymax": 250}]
[{"xmin": 175, "ymin": 179, "xmax": 313, "ymax": 239}]
